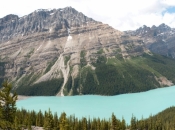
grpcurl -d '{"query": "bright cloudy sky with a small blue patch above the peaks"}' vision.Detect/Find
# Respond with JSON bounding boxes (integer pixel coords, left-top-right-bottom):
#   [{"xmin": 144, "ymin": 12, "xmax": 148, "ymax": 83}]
[{"xmin": 0, "ymin": 0, "xmax": 175, "ymax": 31}]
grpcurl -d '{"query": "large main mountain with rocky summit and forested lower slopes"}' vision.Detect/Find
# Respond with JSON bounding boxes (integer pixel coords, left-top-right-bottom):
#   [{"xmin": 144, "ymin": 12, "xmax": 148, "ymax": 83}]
[{"xmin": 0, "ymin": 7, "xmax": 175, "ymax": 96}]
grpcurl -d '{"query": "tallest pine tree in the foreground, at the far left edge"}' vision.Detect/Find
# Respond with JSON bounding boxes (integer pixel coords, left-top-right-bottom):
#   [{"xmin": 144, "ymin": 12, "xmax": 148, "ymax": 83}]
[{"xmin": 0, "ymin": 81, "xmax": 17, "ymax": 130}]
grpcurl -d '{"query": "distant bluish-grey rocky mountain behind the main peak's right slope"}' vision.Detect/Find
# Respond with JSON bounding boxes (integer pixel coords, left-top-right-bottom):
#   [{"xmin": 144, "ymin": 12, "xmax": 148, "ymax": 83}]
[{"xmin": 125, "ymin": 24, "xmax": 175, "ymax": 58}]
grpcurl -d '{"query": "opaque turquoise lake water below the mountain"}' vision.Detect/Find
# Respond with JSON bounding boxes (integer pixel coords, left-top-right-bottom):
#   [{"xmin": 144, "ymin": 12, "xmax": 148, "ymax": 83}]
[{"xmin": 17, "ymin": 86, "xmax": 175, "ymax": 123}]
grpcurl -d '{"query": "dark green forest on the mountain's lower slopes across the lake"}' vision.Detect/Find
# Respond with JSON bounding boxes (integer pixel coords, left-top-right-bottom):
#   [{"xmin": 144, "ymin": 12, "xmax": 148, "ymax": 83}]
[{"xmin": 16, "ymin": 51, "xmax": 175, "ymax": 95}]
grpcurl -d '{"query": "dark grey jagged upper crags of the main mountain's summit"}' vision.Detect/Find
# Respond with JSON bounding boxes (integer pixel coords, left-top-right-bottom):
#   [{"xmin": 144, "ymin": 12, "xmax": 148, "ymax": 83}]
[{"xmin": 0, "ymin": 7, "xmax": 98, "ymax": 42}]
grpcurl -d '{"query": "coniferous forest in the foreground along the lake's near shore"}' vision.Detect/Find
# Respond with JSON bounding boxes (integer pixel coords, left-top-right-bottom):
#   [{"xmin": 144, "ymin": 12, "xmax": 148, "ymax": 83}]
[{"xmin": 0, "ymin": 81, "xmax": 175, "ymax": 130}]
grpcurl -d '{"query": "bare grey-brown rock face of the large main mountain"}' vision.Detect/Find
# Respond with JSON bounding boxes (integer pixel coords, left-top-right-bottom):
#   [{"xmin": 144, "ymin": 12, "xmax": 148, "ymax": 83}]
[{"xmin": 0, "ymin": 7, "xmax": 174, "ymax": 95}]
